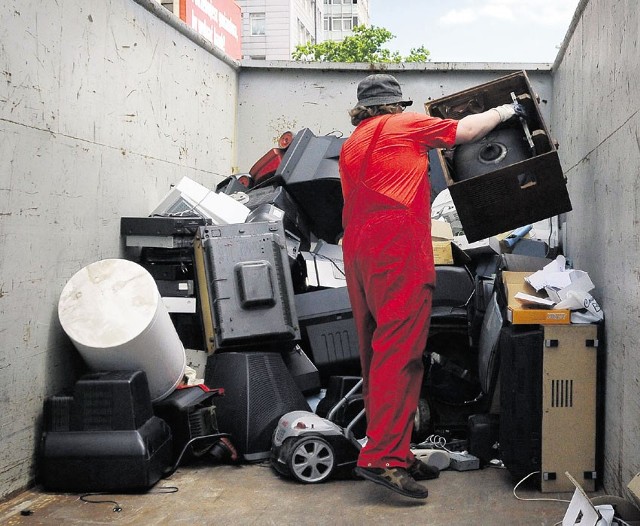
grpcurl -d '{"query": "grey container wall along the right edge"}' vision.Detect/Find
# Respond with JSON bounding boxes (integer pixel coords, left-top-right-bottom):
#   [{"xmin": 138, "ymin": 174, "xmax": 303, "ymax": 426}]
[{"xmin": 552, "ymin": 0, "xmax": 640, "ymax": 500}]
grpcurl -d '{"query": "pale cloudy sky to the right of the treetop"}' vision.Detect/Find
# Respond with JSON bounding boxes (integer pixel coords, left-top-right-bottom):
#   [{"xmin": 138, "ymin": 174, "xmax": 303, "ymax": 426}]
[{"xmin": 369, "ymin": 0, "xmax": 579, "ymax": 63}]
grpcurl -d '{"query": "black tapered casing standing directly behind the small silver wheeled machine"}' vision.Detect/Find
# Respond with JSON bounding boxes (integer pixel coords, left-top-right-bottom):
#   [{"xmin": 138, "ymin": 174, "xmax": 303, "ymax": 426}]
[{"xmin": 205, "ymin": 351, "xmax": 311, "ymax": 462}]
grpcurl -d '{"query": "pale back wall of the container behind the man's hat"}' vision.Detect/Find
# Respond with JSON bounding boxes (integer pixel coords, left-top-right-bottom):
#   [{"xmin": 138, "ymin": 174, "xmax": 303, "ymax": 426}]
[{"xmin": 238, "ymin": 61, "xmax": 553, "ymax": 172}]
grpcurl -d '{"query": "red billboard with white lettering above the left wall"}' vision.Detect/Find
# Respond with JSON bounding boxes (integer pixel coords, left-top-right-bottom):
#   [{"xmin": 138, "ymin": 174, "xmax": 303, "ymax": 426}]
[{"xmin": 180, "ymin": 0, "xmax": 242, "ymax": 60}]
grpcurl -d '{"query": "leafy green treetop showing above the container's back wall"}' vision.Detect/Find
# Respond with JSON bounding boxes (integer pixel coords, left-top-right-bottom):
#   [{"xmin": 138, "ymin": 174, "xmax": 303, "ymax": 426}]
[{"xmin": 291, "ymin": 26, "xmax": 430, "ymax": 63}]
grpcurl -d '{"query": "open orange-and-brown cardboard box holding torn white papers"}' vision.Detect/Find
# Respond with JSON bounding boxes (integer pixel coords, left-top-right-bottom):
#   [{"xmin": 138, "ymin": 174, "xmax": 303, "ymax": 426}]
[{"xmin": 502, "ymin": 271, "xmax": 571, "ymax": 325}]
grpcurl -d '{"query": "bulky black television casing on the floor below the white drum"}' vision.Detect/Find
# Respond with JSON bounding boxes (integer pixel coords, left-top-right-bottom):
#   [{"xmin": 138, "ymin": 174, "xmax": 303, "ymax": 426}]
[{"xmin": 40, "ymin": 371, "xmax": 172, "ymax": 492}]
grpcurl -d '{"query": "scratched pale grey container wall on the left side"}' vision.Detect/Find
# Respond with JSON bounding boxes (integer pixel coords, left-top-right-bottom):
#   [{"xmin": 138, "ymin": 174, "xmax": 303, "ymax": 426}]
[{"xmin": 0, "ymin": 0, "xmax": 237, "ymax": 497}]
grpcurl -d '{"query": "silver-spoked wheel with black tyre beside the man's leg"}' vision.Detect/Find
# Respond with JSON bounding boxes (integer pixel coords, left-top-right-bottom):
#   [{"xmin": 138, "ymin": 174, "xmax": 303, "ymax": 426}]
[{"xmin": 287, "ymin": 437, "xmax": 336, "ymax": 484}]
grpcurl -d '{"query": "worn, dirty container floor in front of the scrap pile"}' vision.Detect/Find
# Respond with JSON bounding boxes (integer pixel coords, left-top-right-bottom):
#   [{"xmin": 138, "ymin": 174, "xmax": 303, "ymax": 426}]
[{"xmin": 0, "ymin": 463, "xmax": 592, "ymax": 526}]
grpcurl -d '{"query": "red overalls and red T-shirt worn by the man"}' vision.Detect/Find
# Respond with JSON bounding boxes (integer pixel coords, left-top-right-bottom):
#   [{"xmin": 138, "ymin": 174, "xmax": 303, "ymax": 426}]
[{"xmin": 339, "ymin": 113, "xmax": 458, "ymax": 468}]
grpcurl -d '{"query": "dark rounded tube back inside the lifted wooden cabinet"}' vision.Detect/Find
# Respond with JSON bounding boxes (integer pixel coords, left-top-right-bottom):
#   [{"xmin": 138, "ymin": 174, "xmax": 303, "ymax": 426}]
[{"xmin": 451, "ymin": 128, "xmax": 531, "ymax": 182}]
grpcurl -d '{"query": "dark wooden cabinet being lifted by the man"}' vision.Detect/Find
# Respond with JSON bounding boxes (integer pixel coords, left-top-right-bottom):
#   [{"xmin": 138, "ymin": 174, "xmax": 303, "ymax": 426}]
[{"xmin": 425, "ymin": 71, "xmax": 571, "ymax": 242}]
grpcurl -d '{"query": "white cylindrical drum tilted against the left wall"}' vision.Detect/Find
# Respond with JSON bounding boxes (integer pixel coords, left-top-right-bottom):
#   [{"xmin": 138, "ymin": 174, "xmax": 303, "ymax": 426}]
[{"xmin": 58, "ymin": 259, "xmax": 186, "ymax": 402}]
